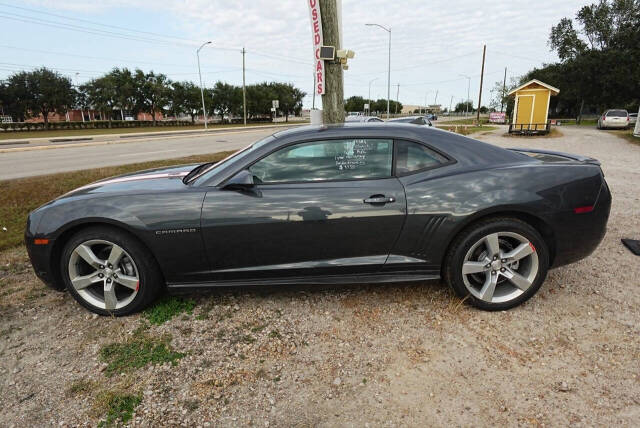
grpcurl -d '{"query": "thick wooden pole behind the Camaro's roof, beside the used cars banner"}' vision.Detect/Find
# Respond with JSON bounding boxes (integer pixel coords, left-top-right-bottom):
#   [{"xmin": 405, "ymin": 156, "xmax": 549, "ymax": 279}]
[{"xmin": 319, "ymin": 0, "xmax": 344, "ymax": 124}]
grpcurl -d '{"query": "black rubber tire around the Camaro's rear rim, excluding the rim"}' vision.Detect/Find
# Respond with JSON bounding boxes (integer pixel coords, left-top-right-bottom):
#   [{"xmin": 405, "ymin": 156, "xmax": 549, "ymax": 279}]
[{"xmin": 443, "ymin": 217, "xmax": 549, "ymax": 311}]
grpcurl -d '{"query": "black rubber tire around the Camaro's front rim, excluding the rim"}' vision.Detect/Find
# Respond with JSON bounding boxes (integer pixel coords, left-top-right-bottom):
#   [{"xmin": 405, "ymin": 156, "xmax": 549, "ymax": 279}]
[{"xmin": 60, "ymin": 226, "xmax": 164, "ymax": 316}]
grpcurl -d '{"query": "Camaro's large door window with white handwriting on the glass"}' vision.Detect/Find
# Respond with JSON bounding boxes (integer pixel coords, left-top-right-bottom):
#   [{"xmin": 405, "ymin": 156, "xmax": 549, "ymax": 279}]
[{"xmin": 249, "ymin": 138, "xmax": 393, "ymax": 183}]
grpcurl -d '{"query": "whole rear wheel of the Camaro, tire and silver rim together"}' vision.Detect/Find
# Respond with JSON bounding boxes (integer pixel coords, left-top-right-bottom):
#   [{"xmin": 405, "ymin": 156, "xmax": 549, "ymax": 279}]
[{"xmin": 444, "ymin": 218, "xmax": 549, "ymax": 310}]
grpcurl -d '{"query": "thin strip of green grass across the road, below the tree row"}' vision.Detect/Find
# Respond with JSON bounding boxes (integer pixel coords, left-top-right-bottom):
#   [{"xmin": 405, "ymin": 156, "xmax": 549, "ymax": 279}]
[{"xmin": 0, "ymin": 122, "xmax": 306, "ymax": 141}]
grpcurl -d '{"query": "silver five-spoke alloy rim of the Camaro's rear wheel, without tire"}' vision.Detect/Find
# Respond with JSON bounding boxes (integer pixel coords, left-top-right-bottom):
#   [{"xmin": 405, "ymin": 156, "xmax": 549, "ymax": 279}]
[{"xmin": 462, "ymin": 232, "xmax": 539, "ymax": 303}]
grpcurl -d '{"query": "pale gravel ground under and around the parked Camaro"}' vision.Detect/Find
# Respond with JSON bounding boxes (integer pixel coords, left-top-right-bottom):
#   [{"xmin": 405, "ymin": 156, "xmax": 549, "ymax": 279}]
[{"xmin": 0, "ymin": 123, "xmax": 640, "ymax": 427}]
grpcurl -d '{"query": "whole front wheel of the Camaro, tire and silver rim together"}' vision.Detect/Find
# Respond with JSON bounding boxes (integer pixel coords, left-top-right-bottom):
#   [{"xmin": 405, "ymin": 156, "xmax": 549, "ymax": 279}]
[{"xmin": 61, "ymin": 227, "xmax": 162, "ymax": 316}]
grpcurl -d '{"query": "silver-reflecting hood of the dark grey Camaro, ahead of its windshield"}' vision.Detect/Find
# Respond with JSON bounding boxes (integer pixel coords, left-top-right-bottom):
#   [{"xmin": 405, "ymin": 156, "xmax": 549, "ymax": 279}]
[{"xmin": 62, "ymin": 164, "xmax": 198, "ymax": 197}]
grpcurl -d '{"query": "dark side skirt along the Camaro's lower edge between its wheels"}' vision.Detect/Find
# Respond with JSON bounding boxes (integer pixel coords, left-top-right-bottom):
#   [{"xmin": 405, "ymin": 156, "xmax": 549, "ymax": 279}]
[{"xmin": 167, "ymin": 272, "xmax": 440, "ymax": 290}]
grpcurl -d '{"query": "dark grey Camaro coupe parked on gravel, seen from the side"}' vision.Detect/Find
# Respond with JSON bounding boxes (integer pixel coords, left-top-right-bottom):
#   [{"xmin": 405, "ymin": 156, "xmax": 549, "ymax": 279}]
[{"xmin": 25, "ymin": 123, "xmax": 611, "ymax": 315}]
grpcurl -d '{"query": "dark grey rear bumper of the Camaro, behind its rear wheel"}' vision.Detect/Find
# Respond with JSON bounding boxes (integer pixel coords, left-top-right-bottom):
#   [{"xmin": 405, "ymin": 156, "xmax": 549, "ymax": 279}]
[{"xmin": 552, "ymin": 179, "xmax": 611, "ymax": 267}]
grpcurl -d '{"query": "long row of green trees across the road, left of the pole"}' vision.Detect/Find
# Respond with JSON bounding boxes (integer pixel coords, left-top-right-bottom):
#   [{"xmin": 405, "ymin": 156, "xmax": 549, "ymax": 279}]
[{"xmin": 0, "ymin": 68, "xmax": 306, "ymax": 126}]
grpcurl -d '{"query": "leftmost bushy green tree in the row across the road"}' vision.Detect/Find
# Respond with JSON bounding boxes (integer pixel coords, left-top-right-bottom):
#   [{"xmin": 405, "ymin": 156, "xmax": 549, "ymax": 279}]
[{"xmin": 6, "ymin": 67, "xmax": 75, "ymax": 128}]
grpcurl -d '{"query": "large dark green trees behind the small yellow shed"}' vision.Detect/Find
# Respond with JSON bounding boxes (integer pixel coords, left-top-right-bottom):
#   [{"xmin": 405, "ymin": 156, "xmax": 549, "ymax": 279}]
[{"xmin": 492, "ymin": 0, "xmax": 640, "ymax": 119}]
